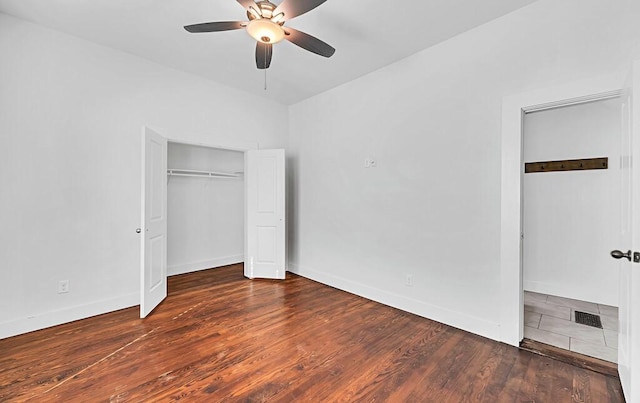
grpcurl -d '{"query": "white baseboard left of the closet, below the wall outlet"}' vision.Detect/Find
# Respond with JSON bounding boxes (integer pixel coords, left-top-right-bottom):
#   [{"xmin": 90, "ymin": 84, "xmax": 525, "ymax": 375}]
[{"xmin": 0, "ymin": 293, "xmax": 140, "ymax": 339}]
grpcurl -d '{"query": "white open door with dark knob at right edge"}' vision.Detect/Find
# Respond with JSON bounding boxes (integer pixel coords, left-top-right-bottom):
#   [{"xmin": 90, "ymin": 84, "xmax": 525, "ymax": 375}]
[{"xmin": 612, "ymin": 63, "xmax": 640, "ymax": 402}]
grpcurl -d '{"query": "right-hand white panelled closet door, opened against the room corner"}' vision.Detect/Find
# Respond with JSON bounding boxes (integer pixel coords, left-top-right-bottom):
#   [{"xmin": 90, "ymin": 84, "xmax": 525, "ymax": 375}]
[{"xmin": 244, "ymin": 150, "xmax": 286, "ymax": 279}]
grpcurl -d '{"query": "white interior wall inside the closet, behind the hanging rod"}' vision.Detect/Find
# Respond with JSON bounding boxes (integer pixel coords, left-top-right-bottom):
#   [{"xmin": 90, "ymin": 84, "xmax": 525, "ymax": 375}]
[{"xmin": 167, "ymin": 143, "xmax": 244, "ymax": 275}]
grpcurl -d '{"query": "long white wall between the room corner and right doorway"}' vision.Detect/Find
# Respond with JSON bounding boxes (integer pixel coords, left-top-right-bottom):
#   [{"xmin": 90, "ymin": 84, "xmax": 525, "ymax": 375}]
[{"xmin": 289, "ymin": 0, "xmax": 640, "ymax": 339}]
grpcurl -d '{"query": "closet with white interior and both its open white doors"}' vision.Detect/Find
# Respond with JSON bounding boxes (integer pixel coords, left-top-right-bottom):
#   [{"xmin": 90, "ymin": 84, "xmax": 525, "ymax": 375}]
[{"xmin": 142, "ymin": 127, "xmax": 286, "ymax": 318}]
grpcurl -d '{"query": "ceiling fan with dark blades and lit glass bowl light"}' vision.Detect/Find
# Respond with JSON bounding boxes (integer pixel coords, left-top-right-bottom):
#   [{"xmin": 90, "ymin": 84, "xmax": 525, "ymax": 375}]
[{"xmin": 184, "ymin": 0, "xmax": 336, "ymax": 69}]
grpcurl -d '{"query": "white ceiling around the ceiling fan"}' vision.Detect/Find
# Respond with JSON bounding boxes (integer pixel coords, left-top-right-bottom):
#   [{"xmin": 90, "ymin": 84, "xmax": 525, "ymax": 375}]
[{"xmin": 0, "ymin": 0, "xmax": 535, "ymax": 104}]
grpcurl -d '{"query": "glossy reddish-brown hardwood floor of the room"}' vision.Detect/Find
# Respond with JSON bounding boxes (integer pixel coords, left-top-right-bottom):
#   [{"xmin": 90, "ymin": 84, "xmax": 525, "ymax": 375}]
[{"xmin": 0, "ymin": 265, "xmax": 624, "ymax": 403}]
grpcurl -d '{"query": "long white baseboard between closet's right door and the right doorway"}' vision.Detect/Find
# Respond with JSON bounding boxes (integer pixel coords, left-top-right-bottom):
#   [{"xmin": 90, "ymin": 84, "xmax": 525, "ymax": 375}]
[{"xmin": 288, "ymin": 263, "xmax": 500, "ymax": 341}]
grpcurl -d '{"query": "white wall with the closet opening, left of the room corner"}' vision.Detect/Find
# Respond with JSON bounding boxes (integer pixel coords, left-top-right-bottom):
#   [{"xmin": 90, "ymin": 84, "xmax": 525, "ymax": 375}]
[{"xmin": 0, "ymin": 14, "xmax": 288, "ymax": 337}]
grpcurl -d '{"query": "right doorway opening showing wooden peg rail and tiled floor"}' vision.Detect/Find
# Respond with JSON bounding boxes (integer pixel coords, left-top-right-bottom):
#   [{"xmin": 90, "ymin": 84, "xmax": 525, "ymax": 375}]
[{"xmin": 522, "ymin": 97, "xmax": 621, "ymax": 362}]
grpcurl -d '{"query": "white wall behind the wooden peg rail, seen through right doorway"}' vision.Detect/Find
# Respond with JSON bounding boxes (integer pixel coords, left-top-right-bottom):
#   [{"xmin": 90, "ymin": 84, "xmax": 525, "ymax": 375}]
[{"xmin": 522, "ymin": 98, "xmax": 622, "ymax": 306}]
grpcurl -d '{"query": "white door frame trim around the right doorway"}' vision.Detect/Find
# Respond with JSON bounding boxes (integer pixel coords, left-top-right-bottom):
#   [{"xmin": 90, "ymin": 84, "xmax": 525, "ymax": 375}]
[{"xmin": 499, "ymin": 74, "xmax": 625, "ymax": 347}]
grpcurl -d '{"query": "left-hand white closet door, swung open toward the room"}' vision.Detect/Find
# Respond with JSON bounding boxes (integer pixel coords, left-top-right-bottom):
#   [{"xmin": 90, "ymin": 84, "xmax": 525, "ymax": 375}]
[{"xmin": 140, "ymin": 128, "xmax": 167, "ymax": 318}]
